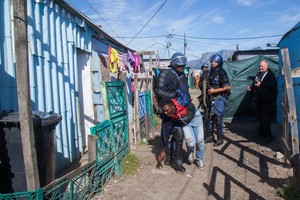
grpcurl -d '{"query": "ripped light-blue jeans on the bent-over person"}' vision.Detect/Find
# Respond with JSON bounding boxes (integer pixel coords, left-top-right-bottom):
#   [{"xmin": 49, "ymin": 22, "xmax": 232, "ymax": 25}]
[{"xmin": 183, "ymin": 110, "xmax": 204, "ymax": 160}]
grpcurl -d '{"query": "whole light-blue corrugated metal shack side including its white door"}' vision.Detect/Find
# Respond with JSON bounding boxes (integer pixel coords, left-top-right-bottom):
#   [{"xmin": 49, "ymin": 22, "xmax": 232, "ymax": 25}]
[{"xmin": 0, "ymin": 0, "xmax": 132, "ymax": 172}]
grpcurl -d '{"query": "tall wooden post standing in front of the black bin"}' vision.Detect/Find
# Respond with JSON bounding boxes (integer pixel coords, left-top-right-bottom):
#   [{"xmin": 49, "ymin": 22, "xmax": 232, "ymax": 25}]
[{"xmin": 12, "ymin": 0, "xmax": 40, "ymax": 190}]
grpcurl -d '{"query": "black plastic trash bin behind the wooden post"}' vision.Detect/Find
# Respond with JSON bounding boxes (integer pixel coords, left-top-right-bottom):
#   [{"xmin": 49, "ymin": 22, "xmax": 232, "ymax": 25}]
[{"xmin": 0, "ymin": 111, "xmax": 62, "ymax": 193}]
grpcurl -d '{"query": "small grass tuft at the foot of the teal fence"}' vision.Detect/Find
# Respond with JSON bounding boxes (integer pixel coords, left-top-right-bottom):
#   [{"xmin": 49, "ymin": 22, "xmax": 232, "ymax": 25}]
[{"xmin": 122, "ymin": 153, "xmax": 140, "ymax": 176}]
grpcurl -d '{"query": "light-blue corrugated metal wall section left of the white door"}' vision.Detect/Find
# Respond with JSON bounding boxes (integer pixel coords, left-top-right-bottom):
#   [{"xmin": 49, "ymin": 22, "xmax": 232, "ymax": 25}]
[{"xmin": 0, "ymin": 0, "xmax": 98, "ymax": 171}]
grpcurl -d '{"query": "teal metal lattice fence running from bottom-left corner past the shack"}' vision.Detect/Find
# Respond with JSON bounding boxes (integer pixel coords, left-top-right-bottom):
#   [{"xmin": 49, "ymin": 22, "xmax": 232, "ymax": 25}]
[{"xmin": 0, "ymin": 82, "xmax": 129, "ymax": 200}]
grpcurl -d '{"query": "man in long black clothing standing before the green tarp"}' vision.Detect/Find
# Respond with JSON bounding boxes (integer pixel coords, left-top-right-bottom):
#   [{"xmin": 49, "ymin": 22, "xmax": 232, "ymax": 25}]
[{"xmin": 248, "ymin": 60, "xmax": 277, "ymax": 142}]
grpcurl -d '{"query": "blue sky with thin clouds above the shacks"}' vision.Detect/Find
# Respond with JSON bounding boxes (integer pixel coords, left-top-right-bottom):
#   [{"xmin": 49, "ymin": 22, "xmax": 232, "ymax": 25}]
[{"xmin": 65, "ymin": 0, "xmax": 300, "ymax": 60}]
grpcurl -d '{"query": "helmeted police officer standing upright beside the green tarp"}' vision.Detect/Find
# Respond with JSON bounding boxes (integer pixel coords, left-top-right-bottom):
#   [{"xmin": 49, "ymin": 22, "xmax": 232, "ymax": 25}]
[{"xmin": 207, "ymin": 54, "xmax": 231, "ymax": 146}]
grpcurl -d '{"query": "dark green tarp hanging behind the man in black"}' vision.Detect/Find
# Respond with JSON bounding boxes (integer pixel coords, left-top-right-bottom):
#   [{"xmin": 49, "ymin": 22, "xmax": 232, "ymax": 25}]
[{"xmin": 223, "ymin": 56, "xmax": 278, "ymax": 122}]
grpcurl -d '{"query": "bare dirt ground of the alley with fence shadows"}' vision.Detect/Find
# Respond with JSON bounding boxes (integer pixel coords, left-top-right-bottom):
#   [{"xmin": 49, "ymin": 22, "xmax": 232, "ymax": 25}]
[{"xmin": 94, "ymin": 89, "xmax": 293, "ymax": 200}]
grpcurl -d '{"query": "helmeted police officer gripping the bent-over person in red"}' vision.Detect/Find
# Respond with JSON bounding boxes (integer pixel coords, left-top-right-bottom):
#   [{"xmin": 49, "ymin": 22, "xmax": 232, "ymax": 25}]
[{"xmin": 157, "ymin": 52, "xmax": 190, "ymax": 173}]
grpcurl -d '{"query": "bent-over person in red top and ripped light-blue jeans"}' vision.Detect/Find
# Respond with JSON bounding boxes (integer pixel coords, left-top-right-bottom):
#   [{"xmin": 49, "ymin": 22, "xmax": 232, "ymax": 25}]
[{"xmin": 159, "ymin": 98, "xmax": 204, "ymax": 169}]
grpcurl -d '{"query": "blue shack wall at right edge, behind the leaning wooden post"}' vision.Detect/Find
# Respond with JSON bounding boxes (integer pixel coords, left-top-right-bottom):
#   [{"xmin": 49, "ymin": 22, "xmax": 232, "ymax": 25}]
[{"xmin": 277, "ymin": 22, "xmax": 300, "ymax": 140}]
